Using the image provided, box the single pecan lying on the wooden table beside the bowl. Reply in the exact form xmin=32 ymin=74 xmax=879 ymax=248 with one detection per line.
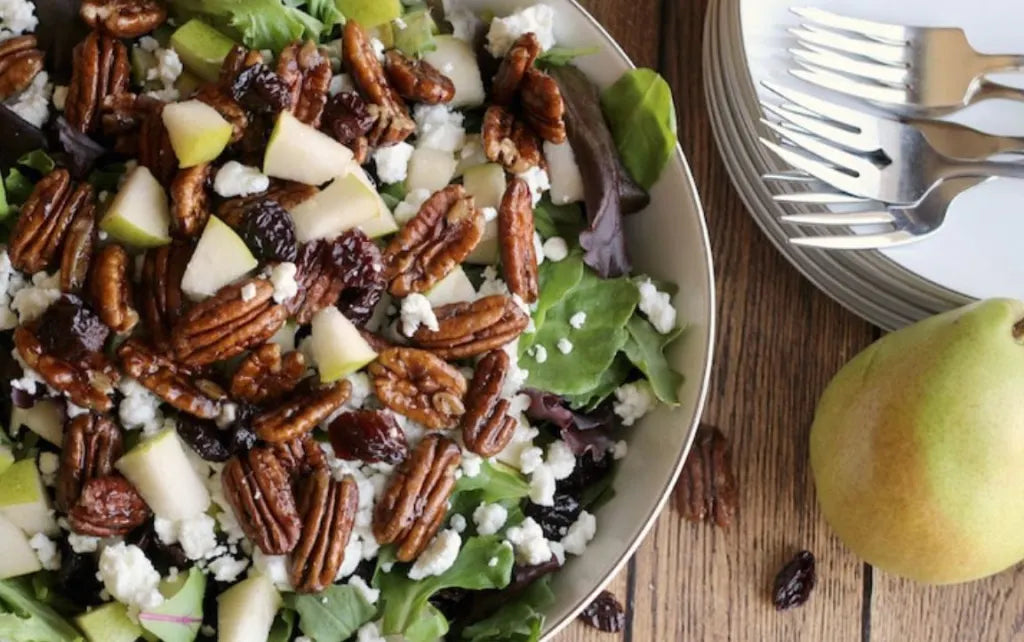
xmin=676 ymin=425 xmax=737 ymax=528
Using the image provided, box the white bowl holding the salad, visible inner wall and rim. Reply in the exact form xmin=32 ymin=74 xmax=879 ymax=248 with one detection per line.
xmin=463 ymin=0 xmax=715 ymax=640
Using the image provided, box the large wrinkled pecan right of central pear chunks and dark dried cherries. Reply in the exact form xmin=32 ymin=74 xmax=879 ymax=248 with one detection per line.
xmin=384 ymin=185 xmax=483 ymax=297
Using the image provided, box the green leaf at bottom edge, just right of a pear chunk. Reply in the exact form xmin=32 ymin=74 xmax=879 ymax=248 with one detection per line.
xmin=285 ymin=584 xmax=377 ymax=642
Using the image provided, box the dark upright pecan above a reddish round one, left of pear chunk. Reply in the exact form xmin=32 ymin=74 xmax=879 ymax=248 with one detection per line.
xmin=55 ymin=413 xmax=124 ymax=513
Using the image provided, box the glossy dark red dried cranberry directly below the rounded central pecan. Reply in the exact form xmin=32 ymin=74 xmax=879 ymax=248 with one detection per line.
xmin=328 ymin=411 xmax=409 ymax=464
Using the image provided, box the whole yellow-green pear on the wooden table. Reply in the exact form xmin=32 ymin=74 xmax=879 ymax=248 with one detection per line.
xmin=810 ymin=299 xmax=1024 ymax=584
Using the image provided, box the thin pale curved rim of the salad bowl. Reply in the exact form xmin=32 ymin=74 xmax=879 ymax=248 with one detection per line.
xmin=541 ymin=0 xmax=718 ymax=642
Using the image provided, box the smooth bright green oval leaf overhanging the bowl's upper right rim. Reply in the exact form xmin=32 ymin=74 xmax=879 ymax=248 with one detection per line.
xmin=601 ymin=69 xmax=678 ymax=189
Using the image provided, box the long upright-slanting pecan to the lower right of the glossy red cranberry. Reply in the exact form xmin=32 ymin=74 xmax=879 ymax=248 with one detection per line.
xmin=373 ymin=433 xmax=462 ymax=562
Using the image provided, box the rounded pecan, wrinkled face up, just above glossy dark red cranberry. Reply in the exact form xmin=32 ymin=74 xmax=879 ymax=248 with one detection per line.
xmin=370 ymin=348 xmax=466 ymax=430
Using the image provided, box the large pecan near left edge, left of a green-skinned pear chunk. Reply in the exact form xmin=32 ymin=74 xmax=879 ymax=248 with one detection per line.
xmin=7 ymin=169 xmax=94 ymax=273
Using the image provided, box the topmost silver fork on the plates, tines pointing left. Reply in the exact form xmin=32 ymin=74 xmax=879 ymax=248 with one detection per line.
xmin=791 ymin=7 xmax=1024 ymax=115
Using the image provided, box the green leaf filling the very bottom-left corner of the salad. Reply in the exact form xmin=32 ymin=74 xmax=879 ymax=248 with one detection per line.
xmin=0 ymin=579 xmax=84 ymax=642
